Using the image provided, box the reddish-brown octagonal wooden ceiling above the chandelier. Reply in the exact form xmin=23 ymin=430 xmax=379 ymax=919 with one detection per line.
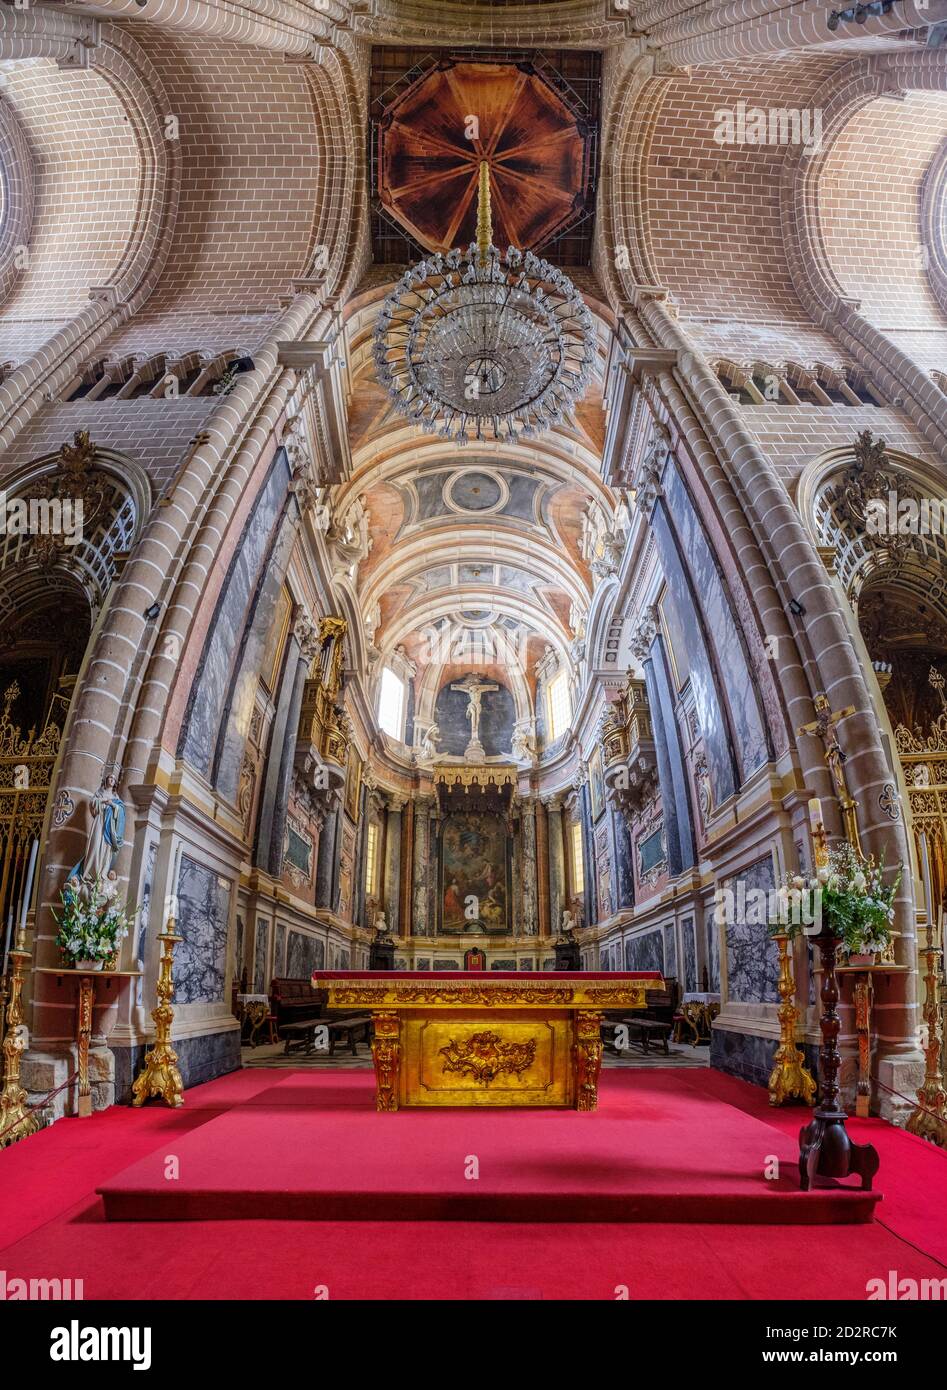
xmin=377 ymin=58 xmax=594 ymax=252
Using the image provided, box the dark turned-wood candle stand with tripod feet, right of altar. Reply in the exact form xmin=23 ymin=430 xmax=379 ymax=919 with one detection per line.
xmin=800 ymin=931 xmax=879 ymax=1193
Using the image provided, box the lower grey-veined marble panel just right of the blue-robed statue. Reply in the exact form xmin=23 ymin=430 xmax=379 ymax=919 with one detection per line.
xmin=174 ymin=855 xmax=231 ymax=1004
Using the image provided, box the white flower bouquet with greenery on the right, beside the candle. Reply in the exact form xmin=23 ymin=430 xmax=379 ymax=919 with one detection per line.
xmin=769 ymin=842 xmax=903 ymax=956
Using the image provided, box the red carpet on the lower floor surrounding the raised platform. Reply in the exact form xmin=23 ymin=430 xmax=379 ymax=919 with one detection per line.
xmin=0 ymin=1070 xmax=947 ymax=1301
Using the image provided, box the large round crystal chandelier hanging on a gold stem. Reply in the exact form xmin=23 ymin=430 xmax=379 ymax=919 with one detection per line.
xmin=374 ymin=161 xmax=595 ymax=445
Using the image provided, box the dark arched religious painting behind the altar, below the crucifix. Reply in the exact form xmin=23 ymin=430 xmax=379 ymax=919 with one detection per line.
xmin=438 ymin=812 xmax=512 ymax=935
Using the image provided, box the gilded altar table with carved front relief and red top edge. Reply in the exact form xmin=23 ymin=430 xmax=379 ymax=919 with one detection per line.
xmin=313 ymin=970 xmax=665 ymax=1111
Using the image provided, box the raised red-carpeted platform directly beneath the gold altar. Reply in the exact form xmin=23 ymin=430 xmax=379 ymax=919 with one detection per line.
xmin=97 ymin=1070 xmax=879 ymax=1225
